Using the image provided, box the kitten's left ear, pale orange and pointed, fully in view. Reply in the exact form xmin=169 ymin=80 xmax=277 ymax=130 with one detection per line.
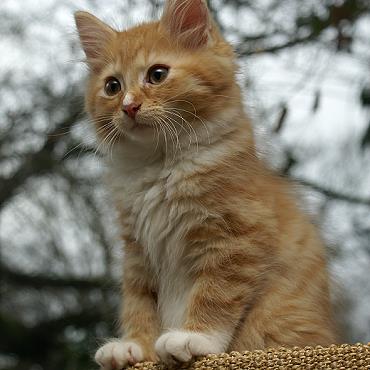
xmin=75 ymin=11 xmax=116 ymax=68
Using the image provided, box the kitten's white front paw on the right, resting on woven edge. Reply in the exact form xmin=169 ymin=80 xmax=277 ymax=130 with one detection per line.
xmin=155 ymin=330 xmax=225 ymax=364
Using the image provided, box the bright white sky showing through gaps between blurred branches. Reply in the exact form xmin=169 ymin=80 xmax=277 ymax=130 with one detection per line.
xmin=0 ymin=0 xmax=370 ymax=340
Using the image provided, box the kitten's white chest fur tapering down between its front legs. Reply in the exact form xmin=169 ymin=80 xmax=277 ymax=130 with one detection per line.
xmin=110 ymin=146 xmax=200 ymax=328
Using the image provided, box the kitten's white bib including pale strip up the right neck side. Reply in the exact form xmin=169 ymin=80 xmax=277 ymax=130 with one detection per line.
xmin=110 ymin=122 xmax=240 ymax=328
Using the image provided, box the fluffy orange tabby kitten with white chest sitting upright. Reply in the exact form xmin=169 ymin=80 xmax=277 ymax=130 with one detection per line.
xmin=76 ymin=0 xmax=335 ymax=369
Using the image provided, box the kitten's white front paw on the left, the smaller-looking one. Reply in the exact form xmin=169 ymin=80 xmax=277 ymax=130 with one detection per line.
xmin=95 ymin=340 xmax=143 ymax=370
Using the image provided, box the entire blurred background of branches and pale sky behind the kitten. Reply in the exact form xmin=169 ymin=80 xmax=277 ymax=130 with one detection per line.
xmin=0 ymin=0 xmax=370 ymax=370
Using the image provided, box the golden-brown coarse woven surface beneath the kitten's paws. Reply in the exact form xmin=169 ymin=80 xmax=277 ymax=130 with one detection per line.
xmin=129 ymin=343 xmax=370 ymax=370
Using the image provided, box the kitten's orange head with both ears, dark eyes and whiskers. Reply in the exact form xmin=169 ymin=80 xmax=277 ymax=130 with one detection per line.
xmin=75 ymin=0 xmax=243 ymax=151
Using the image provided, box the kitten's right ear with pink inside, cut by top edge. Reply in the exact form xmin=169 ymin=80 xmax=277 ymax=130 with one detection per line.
xmin=161 ymin=0 xmax=211 ymax=48
